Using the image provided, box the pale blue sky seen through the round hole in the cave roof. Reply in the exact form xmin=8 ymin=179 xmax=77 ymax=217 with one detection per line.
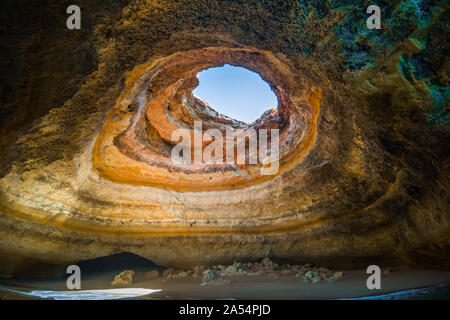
xmin=193 ymin=64 xmax=278 ymax=122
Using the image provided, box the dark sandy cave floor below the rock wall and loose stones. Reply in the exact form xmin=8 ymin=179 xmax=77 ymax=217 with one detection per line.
xmin=0 ymin=267 xmax=450 ymax=300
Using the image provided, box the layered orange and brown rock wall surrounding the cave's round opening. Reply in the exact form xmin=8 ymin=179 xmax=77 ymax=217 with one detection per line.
xmin=0 ymin=0 xmax=450 ymax=275
